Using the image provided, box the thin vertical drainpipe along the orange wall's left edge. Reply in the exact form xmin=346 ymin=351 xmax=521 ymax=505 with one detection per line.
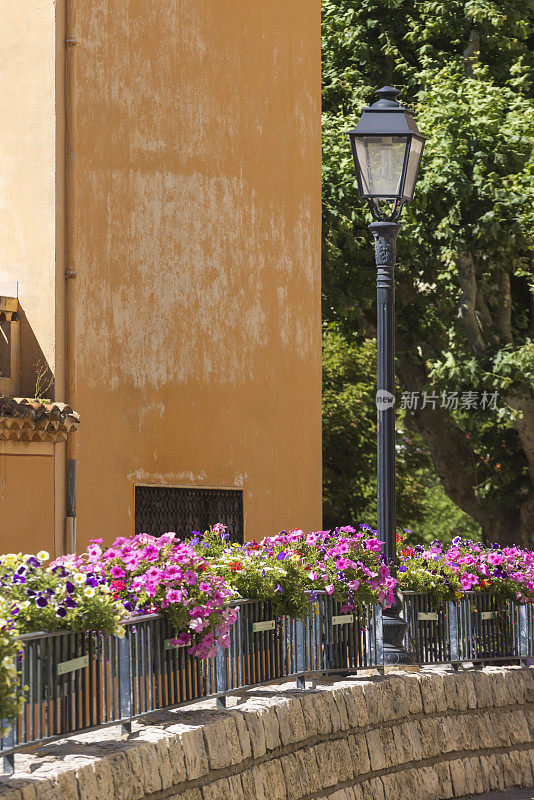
xmin=64 ymin=0 xmax=77 ymax=553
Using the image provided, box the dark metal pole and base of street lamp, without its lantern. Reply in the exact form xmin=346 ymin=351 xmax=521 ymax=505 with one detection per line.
xmin=369 ymin=222 xmax=412 ymax=664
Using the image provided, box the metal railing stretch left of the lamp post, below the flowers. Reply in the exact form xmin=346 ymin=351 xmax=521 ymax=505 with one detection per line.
xmin=0 ymin=594 xmax=383 ymax=772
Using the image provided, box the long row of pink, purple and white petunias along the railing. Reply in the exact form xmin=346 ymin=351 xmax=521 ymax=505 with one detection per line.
xmin=0 ymin=524 xmax=534 ymax=719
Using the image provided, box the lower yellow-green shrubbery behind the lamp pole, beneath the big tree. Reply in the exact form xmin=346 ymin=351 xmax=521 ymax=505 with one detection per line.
xmin=323 ymin=323 xmax=480 ymax=544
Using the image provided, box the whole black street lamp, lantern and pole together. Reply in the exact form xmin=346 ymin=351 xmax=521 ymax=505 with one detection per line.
xmin=349 ymin=86 xmax=425 ymax=664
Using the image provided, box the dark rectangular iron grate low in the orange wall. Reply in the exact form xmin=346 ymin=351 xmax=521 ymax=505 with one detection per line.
xmin=135 ymin=486 xmax=243 ymax=542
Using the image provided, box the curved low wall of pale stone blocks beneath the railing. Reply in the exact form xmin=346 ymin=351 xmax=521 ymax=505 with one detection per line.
xmin=0 ymin=668 xmax=534 ymax=800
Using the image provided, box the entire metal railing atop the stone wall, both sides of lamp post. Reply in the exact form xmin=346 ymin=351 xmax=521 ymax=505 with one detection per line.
xmin=0 ymin=592 xmax=534 ymax=772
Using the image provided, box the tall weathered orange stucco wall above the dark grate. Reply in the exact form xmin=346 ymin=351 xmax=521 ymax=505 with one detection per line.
xmin=70 ymin=0 xmax=321 ymax=546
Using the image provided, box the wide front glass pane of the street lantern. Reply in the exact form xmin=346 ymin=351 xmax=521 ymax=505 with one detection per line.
xmin=355 ymin=136 xmax=408 ymax=199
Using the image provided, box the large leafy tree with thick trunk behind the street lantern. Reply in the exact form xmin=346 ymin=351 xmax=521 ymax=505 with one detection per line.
xmin=323 ymin=0 xmax=534 ymax=545
